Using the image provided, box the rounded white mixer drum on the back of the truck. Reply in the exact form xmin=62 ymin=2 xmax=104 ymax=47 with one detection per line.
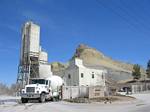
xmin=48 ymin=76 xmax=63 ymax=91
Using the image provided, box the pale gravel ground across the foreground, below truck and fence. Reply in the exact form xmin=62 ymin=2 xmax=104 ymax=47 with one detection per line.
xmin=0 ymin=93 xmax=150 ymax=112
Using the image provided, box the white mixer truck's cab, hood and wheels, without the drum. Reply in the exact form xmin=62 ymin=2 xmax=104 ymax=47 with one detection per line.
xmin=21 ymin=78 xmax=59 ymax=103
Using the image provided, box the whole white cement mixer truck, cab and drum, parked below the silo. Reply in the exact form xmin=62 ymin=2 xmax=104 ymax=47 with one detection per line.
xmin=21 ymin=76 xmax=63 ymax=103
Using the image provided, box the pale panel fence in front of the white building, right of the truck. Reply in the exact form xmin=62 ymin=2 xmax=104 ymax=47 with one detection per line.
xmin=62 ymin=86 xmax=105 ymax=99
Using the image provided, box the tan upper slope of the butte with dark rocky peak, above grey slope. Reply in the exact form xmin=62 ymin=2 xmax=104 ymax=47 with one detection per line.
xmin=73 ymin=44 xmax=145 ymax=72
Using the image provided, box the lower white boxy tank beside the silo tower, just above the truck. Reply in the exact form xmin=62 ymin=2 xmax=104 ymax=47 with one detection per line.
xmin=39 ymin=64 xmax=52 ymax=78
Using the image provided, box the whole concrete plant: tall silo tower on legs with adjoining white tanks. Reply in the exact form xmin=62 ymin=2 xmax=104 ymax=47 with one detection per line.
xmin=17 ymin=21 xmax=52 ymax=87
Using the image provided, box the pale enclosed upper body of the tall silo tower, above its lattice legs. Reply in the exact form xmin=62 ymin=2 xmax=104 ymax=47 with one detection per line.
xmin=20 ymin=22 xmax=40 ymax=64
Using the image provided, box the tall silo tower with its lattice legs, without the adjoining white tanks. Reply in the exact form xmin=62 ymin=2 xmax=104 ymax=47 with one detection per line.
xmin=17 ymin=21 xmax=40 ymax=85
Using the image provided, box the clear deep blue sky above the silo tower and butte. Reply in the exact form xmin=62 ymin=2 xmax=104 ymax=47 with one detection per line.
xmin=0 ymin=0 xmax=150 ymax=85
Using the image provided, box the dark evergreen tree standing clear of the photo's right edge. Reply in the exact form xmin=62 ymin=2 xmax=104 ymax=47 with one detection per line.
xmin=132 ymin=64 xmax=141 ymax=80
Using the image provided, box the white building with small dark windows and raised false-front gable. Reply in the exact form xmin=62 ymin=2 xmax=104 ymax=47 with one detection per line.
xmin=57 ymin=58 xmax=106 ymax=86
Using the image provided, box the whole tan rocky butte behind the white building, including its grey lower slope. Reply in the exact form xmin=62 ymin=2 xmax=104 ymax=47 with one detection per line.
xmin=51 ymin=44 xmax=145 ymax=82
